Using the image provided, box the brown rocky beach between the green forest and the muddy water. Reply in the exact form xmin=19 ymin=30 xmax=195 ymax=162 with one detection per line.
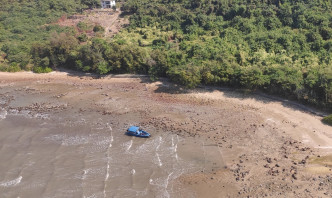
xmin=0 ymin=72 xmax=332 ymax=197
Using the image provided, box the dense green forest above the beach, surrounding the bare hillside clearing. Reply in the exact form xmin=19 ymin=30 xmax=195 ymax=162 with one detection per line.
xmin=0 ymin=0 xmax=332 ymax=110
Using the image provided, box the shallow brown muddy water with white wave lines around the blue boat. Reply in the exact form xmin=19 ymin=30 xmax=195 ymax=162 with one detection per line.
xmin=0 ymin=92 xmax=224 ymax=197
